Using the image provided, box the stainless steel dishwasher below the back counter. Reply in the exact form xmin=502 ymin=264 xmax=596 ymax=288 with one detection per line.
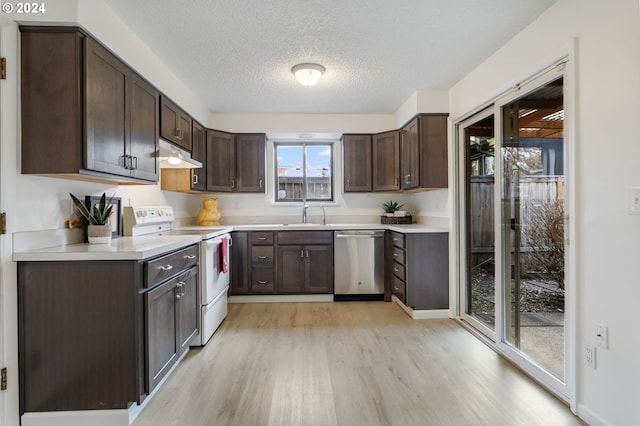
xmin=334 ymin=230 xmax=384 ymax=300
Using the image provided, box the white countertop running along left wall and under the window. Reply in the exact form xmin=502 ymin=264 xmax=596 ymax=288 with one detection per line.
xmin=13 ymin=223 xmax=449 ymax=262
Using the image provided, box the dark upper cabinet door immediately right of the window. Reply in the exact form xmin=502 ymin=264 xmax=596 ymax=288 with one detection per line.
xmin=342 ymin=135 xmax=372 ymax=192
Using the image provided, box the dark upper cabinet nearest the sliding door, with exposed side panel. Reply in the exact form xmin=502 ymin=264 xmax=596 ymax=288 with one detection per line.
xmin=400 ymin=114 xmax=448 ymax=190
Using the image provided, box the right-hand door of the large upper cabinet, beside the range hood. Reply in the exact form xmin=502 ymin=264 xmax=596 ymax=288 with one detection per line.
xmin=128 ymin=73 xmax=159 ymax=182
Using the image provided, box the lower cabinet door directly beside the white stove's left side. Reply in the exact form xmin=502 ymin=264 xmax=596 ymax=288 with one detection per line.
xmin=176 ymin=266 xmax=199 ymax=353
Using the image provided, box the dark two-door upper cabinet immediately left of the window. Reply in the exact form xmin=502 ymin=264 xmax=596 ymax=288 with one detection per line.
xmin=206 ymin=130 xmax=266 ymax=193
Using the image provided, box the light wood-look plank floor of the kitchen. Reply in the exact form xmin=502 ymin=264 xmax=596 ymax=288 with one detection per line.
xmin=134 ymin=302 xmax=582 ymax=426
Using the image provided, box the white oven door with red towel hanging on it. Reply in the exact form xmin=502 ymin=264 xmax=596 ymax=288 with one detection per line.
xmin=200 ymin=234 xmax=231 ymax=306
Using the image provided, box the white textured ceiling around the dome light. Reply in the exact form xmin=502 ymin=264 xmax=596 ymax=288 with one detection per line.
xmin=105 ymin=0 xmax=556 ymax=113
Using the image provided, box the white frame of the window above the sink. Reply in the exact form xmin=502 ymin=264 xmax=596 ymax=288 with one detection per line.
xmin=273 ymin=140 xmax=336 ymax=205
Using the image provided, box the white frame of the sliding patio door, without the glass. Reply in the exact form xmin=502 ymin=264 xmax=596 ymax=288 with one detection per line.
xmin=452 ymin=45 xmax=581 ymax=413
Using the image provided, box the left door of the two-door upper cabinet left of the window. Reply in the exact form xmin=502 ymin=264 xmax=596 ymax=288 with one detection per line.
xmin=207 ymin=130 xmax=236 ymax=192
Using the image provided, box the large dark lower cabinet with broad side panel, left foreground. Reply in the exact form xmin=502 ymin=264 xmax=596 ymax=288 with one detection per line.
xmin=18 ymin=246 xmax=198 ymax=414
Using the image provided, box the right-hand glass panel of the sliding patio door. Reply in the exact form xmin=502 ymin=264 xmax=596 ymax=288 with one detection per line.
xmin=500 ymin=78 xmax=565 ymax=380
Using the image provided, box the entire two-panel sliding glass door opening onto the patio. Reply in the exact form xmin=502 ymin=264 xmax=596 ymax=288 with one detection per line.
xmin=457 ymin=67 xmax=568 ymax=396
